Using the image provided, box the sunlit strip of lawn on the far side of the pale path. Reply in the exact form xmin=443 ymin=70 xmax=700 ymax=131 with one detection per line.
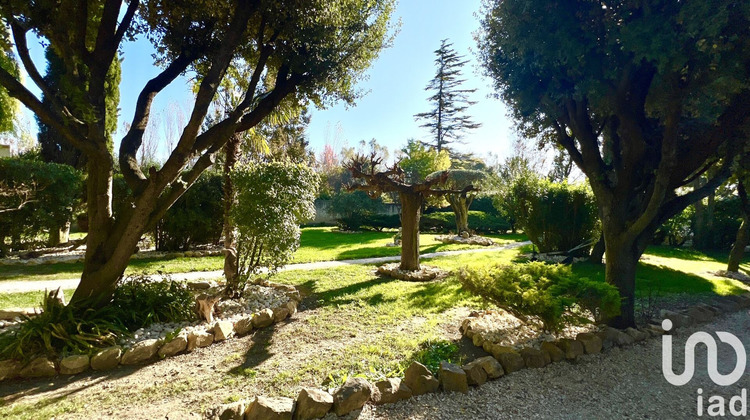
xmin=0 ymin=227 xmax=525 ymax=282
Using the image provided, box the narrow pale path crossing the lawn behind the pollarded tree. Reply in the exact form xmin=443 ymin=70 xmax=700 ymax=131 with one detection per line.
xmin=0 ymin=241 xmax=531 ymax=293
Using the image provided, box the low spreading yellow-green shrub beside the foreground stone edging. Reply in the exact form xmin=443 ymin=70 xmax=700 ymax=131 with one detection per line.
xmin=458 ymin=262 xmax=620 ymax=331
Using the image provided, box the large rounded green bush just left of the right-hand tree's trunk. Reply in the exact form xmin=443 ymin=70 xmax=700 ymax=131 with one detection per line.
xmin=510 ymin=178 xmax=599 ymax=252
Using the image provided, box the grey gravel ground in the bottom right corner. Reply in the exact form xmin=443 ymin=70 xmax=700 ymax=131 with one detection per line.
xmin=357 ymin=311 xmax=750 ymax=420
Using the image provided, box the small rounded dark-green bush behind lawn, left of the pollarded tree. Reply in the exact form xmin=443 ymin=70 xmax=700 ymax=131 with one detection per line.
xmin=328 ymin=191 xmax=388 ymax=231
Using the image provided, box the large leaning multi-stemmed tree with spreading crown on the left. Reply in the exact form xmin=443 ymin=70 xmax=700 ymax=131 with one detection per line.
xmin=0 ymin=0 xmax=393 ymax=305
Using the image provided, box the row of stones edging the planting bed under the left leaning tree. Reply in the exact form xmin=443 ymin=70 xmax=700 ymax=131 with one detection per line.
xmin=0 ymin=282 xmax=302 ymax=381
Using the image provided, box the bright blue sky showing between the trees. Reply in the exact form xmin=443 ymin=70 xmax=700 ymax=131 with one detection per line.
xmin=22 ymin=0 xmax=514 ymax=162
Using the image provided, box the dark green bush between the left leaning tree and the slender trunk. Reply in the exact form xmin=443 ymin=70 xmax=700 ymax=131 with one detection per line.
xmin=155 ymin=172 xmax=224 ymax=251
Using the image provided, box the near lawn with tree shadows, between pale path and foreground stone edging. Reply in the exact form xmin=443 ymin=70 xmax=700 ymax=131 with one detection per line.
xmin=0 ymin=243 xmax=748 ymax=418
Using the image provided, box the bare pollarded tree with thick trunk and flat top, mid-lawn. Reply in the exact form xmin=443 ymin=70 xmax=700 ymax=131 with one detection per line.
xmin=346 ymin=152 xmax=473 ymax=271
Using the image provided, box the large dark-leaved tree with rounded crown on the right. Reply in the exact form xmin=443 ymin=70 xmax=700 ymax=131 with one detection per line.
xmin=477 ymin=0 xmax=750 ymax=327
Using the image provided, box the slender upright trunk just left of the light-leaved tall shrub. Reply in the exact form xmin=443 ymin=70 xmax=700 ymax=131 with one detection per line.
xmin=222 ymin=135 xmax=240 ymax=295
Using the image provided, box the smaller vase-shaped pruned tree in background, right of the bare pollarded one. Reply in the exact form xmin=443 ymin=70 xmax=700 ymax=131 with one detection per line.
xmin=426 ymin=169 xmax=487 ymax=235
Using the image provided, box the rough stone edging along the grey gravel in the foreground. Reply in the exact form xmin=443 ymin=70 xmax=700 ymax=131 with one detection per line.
xmin=205 ymin=293 xmax=750 ymax=420
